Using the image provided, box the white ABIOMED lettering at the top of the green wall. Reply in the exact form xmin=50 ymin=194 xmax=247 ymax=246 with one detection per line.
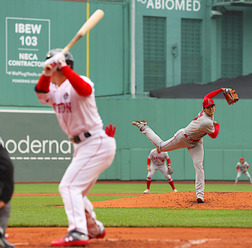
xmin=137 ymin=0 xmax=200 ymax=12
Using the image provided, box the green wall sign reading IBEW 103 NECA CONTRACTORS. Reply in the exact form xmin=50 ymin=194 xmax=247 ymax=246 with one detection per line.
xmin=6 ymin=17 xmax=50 ymax=83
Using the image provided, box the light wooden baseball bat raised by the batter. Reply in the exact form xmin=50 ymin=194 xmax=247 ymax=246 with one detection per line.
xmin=47 ymin=9 xmax=104 ymax=68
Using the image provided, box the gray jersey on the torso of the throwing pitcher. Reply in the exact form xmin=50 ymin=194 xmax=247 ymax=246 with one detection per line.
xmin=185 ymin=110 xmax=215 ymax=140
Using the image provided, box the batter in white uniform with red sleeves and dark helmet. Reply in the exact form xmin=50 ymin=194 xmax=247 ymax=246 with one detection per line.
xmin=35 ymin=49 xmax=116 ymax=246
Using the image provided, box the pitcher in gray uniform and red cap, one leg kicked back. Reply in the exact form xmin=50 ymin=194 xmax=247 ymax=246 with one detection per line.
xmin=132 ymin=88 xmax=225 ymax=203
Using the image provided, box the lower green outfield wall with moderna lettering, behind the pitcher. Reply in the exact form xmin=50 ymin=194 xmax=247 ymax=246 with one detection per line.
xmin=0 ymin=97 xmax=252 ymax=182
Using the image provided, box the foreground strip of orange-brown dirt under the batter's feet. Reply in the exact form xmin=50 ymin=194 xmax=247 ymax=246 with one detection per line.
xmin=8 ymin=227 xmax=252 ymax=248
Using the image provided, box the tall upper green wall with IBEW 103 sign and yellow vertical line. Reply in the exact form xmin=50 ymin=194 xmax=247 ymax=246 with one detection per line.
xmin=0 ymin=0 xmax=130 ymax=106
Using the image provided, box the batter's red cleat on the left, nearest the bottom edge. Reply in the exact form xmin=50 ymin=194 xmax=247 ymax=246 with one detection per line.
xmin=51 ymin=231 xmax=90 ymax=247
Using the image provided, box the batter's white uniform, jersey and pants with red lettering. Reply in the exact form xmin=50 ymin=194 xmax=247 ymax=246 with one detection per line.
xmin=36 ymin=72 xmax=116 ymax=234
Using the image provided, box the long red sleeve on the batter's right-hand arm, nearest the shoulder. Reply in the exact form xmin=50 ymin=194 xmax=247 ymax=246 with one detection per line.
xmin=60 ymin=66 xmax=92 ymax=96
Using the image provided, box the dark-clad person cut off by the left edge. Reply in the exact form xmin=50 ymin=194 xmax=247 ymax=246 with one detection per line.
xmin=0 ymin=138 xmax=15 ymax=248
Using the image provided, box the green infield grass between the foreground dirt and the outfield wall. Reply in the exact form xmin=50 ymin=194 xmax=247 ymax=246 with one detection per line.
xmin=9 ymin=182 xmax=252 ymax=228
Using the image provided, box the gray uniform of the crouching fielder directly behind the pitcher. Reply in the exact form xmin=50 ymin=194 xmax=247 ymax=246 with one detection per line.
xmin=147 ymin=148 xmax=171 ymax=181
